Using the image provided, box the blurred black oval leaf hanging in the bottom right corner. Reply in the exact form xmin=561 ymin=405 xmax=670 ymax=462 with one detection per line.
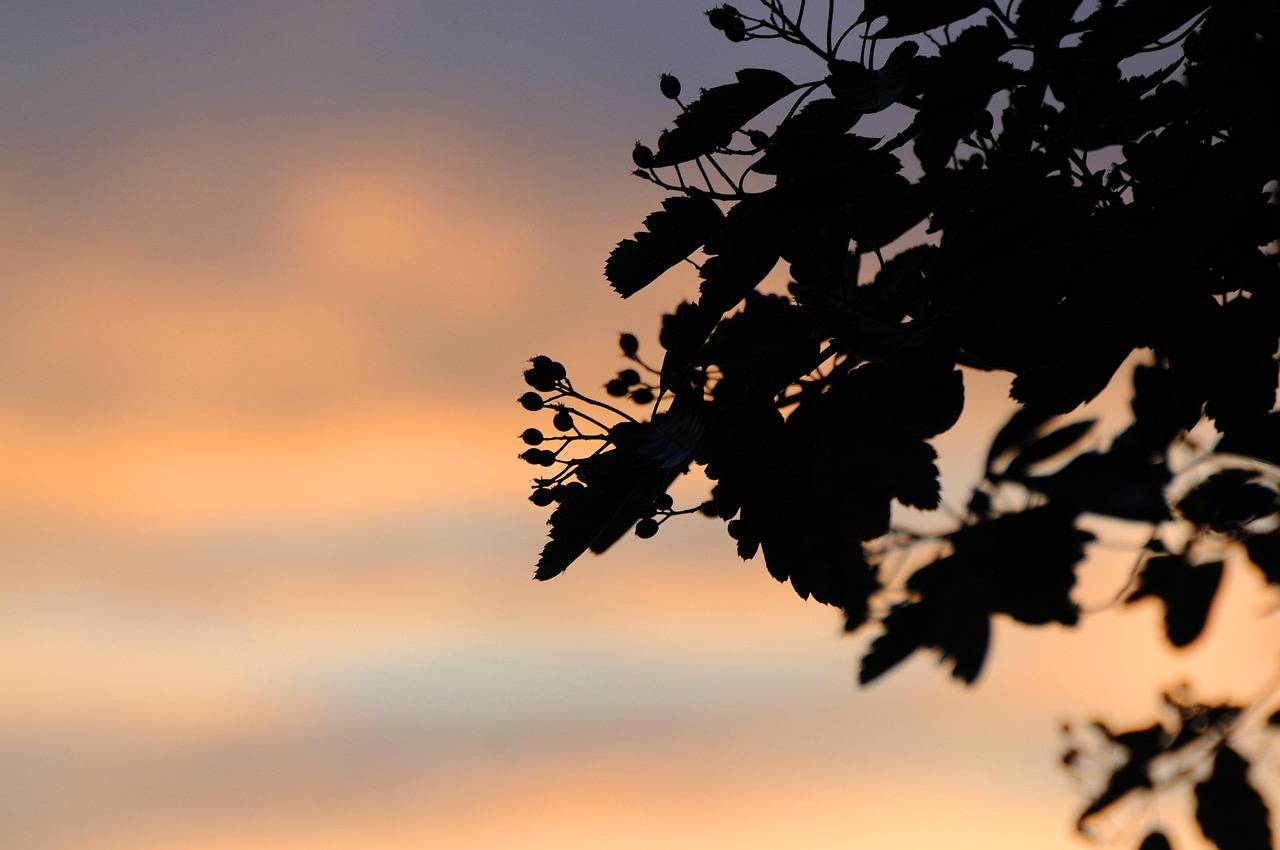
xmin=1196 ymin=746 xmax=1271 ymax=850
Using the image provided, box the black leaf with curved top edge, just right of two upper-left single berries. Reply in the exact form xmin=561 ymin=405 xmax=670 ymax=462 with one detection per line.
xmin=653 ymin=68 xmax=796 ymax=168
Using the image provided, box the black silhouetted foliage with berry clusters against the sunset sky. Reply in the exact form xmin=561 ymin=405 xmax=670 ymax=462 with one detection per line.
xmin=521 ymin=0 xmax=1280 ymax=850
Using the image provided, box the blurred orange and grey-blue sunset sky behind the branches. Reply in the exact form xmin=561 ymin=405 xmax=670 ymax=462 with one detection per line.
xmin=0 ymin=0 xmax=1280 ymax=850
